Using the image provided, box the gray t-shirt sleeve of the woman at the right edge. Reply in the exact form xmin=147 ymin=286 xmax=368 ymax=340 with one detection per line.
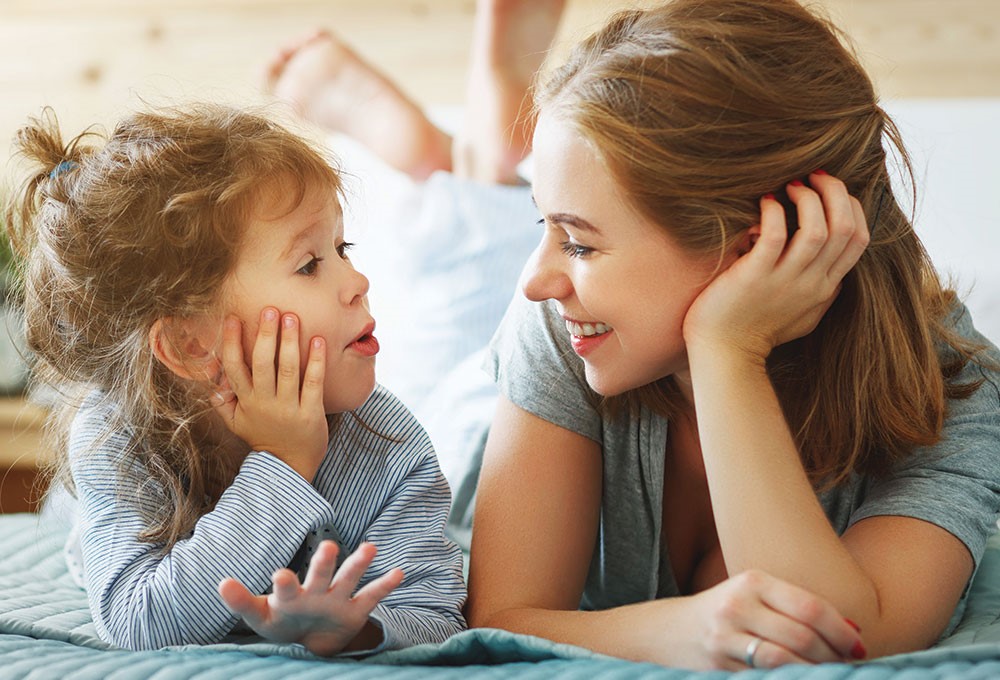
xmin=850 ymin=308 xmax=1000 ymax=568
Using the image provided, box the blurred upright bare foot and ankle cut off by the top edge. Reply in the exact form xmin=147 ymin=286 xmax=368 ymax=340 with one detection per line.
xmin=454 ymin=0 xmax=566 ymax=184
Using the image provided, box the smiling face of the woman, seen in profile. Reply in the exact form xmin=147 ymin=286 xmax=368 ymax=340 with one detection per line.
xmin=522 ymin=112 xmax=719 ymax=396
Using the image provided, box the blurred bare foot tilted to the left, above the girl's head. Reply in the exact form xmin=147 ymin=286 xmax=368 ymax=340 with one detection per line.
xmin=265 ymin=31 xmax=451 ymax=180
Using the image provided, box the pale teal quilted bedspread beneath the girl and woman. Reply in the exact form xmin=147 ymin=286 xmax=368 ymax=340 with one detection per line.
xmin=0 ymin=515 xmax=1000 ymax=680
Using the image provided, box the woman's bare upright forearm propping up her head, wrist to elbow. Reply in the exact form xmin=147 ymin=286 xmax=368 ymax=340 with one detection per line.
xmin=689 ymin=347 xmax=880 ymax=625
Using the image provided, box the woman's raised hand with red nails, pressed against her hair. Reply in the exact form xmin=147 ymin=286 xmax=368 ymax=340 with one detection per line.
xmin=684 ymin=171 xmax=869 ymax=361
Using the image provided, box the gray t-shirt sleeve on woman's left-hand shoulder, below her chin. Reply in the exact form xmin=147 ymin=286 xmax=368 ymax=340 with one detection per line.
xmin=485 ymin=295 xmax=603 ymax=443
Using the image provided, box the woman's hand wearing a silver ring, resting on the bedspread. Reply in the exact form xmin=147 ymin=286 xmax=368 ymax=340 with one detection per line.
xmin=672 ymin=571 xmax=866 ymax=671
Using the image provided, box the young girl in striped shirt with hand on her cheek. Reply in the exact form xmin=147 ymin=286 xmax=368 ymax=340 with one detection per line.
xmin=10 ymin=106 xmax=465 ymax=654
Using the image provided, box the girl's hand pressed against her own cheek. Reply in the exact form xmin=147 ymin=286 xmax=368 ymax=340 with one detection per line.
xmin=215 ymin=307 xmax=330 ymax=482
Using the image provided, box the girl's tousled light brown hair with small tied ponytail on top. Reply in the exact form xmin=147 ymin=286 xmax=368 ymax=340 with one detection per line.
xmin=7 ymin=105 xmax=341 ymax=548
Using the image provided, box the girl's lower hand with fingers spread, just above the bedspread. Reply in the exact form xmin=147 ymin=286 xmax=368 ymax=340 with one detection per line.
xmin=219 ymin=541 xmax=403 ymax=656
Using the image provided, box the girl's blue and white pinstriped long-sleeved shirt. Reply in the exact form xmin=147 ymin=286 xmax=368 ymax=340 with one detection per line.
xmin=67 ymin=386 xmax=465 ymax=651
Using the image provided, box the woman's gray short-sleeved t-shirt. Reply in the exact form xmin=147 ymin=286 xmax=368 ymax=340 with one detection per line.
xmin=487 ymin=296 xmax=1000 ymax=628
